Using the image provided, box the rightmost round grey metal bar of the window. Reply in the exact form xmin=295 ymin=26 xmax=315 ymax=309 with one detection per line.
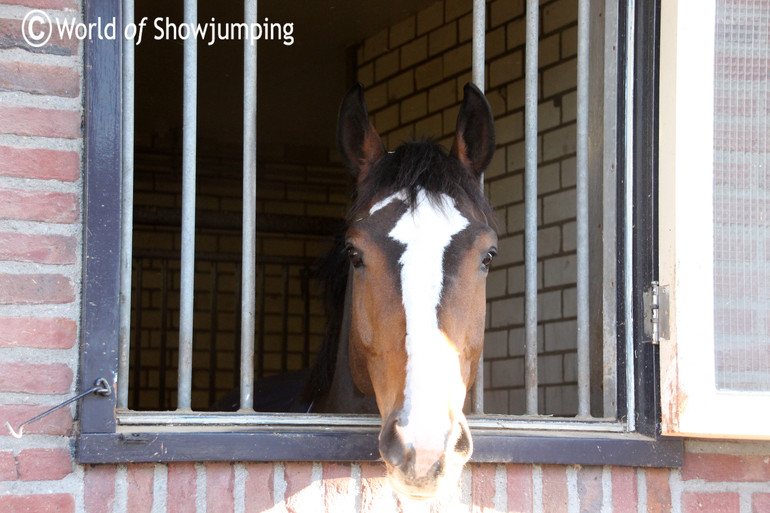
xmin=576 ymin=0 xmax=591 ymax=416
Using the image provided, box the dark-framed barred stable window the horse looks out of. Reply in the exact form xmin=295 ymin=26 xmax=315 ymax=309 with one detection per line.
xmin=79 ymin=0 xmax=682 ymax=465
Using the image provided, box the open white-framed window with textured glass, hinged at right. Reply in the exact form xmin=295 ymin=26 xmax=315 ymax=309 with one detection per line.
xmin=660 ymin=0 xmax=770 ymax=438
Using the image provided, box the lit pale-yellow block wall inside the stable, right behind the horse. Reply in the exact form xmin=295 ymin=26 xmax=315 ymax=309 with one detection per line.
xmin=357 ymin=0 xmax=577 ymax=415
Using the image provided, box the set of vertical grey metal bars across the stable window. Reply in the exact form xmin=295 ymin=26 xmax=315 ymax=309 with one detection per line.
xmin=117 ymin=0 xmax=633 ymax=421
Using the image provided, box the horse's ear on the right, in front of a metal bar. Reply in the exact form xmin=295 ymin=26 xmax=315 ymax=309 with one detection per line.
xmin=450 ymin=83 xmax=495 ymax=176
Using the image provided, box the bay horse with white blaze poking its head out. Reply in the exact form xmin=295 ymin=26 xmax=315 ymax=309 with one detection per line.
xmin=305 ymin=84 xmax=497 ymax=499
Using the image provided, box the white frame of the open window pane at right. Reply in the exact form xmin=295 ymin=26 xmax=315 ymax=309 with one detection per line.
xmin=660 ymin=0 xmax=770 ymax=439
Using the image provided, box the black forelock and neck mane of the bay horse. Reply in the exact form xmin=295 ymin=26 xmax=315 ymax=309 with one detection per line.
xmin=300 ymin=140 xmax=494 ymax=406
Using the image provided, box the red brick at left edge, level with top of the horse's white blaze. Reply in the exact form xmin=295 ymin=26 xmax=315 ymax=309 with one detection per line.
xmin=0 ymin=189 xmax=80 ymax=223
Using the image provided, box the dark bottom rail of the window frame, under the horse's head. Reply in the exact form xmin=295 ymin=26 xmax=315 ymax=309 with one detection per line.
xmin=78 ymin=428 xmax=684 ymax=467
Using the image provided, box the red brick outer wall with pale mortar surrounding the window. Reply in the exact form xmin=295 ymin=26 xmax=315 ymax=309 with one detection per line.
xmin=0 ymin=0 xmax=770 ymax=513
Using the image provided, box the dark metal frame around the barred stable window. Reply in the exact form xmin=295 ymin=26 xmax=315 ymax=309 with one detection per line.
xmin=78 ymin=0 xmax=683 ymax=467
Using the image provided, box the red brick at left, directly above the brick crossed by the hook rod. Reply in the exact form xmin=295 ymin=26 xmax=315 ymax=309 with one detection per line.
xmin=0 ymin=362 xmax=73 ymax=394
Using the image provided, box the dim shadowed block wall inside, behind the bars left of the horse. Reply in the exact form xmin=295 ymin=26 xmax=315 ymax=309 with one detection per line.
xmin=129 ymin=150 xmax=351 ymax=410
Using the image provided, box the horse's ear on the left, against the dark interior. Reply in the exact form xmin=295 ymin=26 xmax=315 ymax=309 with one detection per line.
xmin=337 ymin=84 xmax=385 ymax=182
